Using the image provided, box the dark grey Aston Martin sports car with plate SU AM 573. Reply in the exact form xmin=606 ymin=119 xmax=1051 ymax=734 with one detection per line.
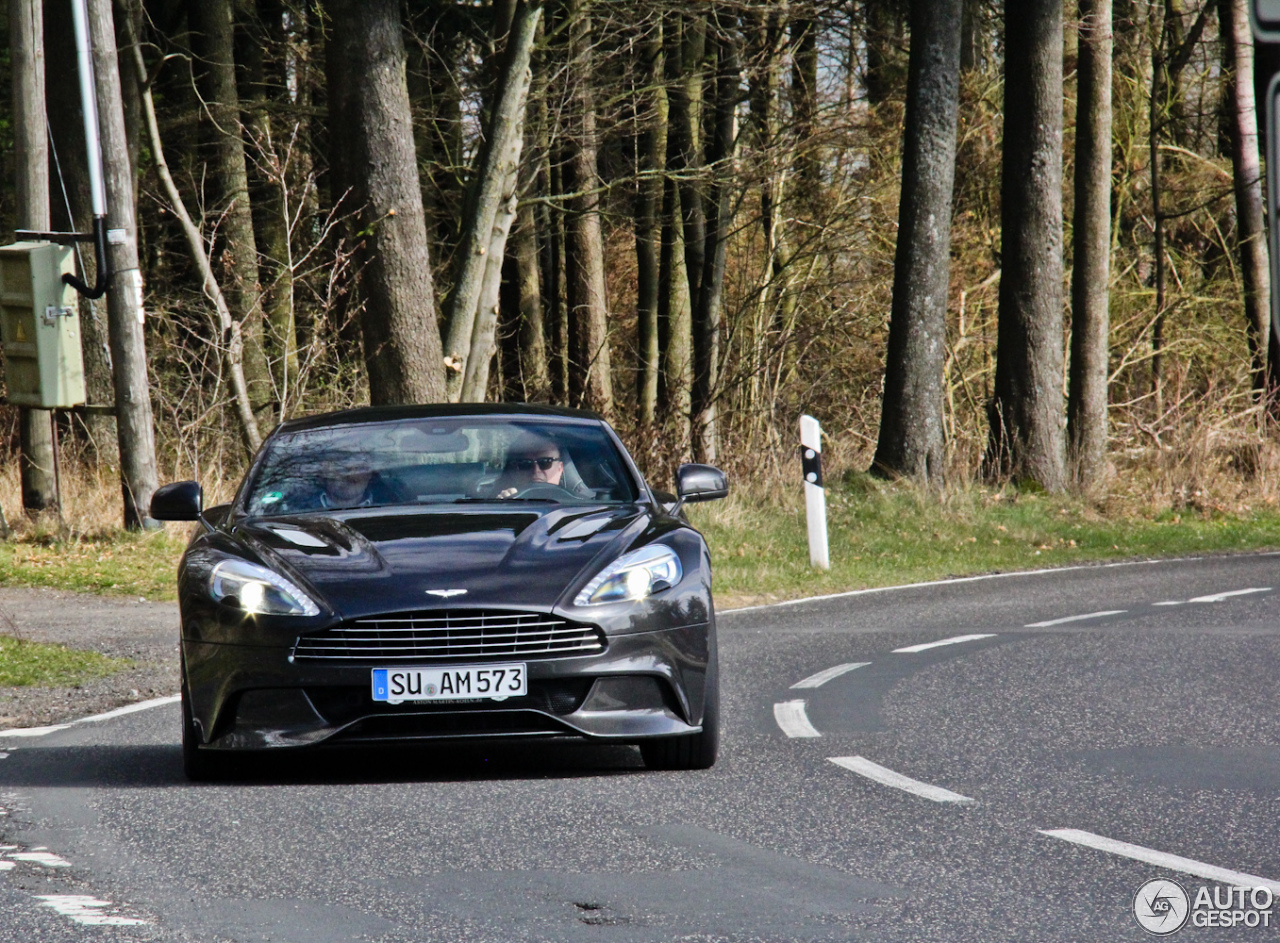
xmin=151 ymin=404 xmax=727 ymax=779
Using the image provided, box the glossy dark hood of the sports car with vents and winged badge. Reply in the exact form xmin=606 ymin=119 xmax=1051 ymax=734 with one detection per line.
xmin=236 ymin=505 xmax=653 ymax=619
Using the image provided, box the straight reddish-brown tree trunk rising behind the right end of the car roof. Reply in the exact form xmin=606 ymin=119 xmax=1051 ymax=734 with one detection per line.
xmin=564 ymin=0 xmax=613 ymax=417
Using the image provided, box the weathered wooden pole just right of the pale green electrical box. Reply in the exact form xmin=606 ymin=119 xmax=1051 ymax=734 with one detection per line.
xmin=88 ymin=0 xmax=157 ymax=530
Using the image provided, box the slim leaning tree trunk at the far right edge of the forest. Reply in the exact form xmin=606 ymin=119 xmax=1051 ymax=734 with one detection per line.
xmin=1220 ymin=0 xmax=1275 ymax=392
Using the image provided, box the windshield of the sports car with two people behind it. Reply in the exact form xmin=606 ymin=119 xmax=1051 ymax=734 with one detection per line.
xmin=246 ymin=418 xmax=637 ymax=516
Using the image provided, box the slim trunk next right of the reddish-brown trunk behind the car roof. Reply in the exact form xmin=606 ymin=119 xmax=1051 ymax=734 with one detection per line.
xmin=635 ymin=17 xmax=667 ymax=426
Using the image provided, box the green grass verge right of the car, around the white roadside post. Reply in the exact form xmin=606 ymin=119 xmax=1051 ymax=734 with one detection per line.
xmin=689 ymin=473 xmax=1280 ymax=609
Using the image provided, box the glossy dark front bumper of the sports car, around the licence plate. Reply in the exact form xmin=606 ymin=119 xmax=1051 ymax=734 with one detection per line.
xmin=182 ymin=622 xmax=716 ymax=750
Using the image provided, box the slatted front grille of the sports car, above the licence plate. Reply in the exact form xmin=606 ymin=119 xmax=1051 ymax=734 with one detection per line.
xmin=293 ymin=609 xmax=604 ymax=664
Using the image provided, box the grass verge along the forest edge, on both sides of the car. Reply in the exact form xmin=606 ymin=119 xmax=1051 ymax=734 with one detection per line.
xmin=0 ymin=473 xmax=1280 ymax=609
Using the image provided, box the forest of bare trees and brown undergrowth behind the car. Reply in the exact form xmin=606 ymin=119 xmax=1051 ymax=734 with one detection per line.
xmin=0 ymin=0 xmax=1280 ymax=603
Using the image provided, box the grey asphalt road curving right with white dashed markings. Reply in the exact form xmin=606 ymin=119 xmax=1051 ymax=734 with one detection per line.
xmin=0 ymin=555 xmax=1280 ymax=943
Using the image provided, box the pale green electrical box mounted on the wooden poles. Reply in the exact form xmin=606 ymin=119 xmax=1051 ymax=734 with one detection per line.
xmin=0 ymin=242 xmax=84 ymax=409
